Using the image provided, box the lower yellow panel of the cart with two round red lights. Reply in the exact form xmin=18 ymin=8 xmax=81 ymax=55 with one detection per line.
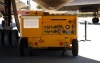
xmin=28 ymin=35 xmax=75 ymax=47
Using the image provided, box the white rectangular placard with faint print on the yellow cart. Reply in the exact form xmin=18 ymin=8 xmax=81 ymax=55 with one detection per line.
xmin=24 ymin=18 xmax=39 ymax=28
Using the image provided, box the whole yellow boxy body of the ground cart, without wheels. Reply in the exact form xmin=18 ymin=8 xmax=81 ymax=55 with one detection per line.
xmin=21 ymin=12 xmax=77 ymax=48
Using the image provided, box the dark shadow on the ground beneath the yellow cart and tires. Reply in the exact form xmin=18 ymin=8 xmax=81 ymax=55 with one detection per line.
xmin=0 ymin=48 xmax=100 ymax=63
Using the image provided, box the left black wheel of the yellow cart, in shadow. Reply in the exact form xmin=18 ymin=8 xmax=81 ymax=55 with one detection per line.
xmin=19 ymin=38 xmax=29 ymax=56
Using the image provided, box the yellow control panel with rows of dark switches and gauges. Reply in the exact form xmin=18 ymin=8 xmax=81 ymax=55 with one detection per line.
xmin=42 ymin=16 xmax=76 ymax=34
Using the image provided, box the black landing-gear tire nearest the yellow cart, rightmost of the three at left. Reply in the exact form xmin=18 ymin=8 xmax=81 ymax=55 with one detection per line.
xmin=11 ymin=30 xmax=18 ymax=47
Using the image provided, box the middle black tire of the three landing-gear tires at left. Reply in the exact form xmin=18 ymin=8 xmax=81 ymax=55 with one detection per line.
xmin=4 ymin=30 xmax=11 ymax=47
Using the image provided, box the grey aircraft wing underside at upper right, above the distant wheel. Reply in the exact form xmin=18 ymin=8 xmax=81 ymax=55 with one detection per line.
xmin=59 ymin=0 xmax=100 ymax=12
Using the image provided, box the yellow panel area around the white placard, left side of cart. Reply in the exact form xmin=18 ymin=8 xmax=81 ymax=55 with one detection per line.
xmin=21 ymin=18 xmax=42 ymax=37
